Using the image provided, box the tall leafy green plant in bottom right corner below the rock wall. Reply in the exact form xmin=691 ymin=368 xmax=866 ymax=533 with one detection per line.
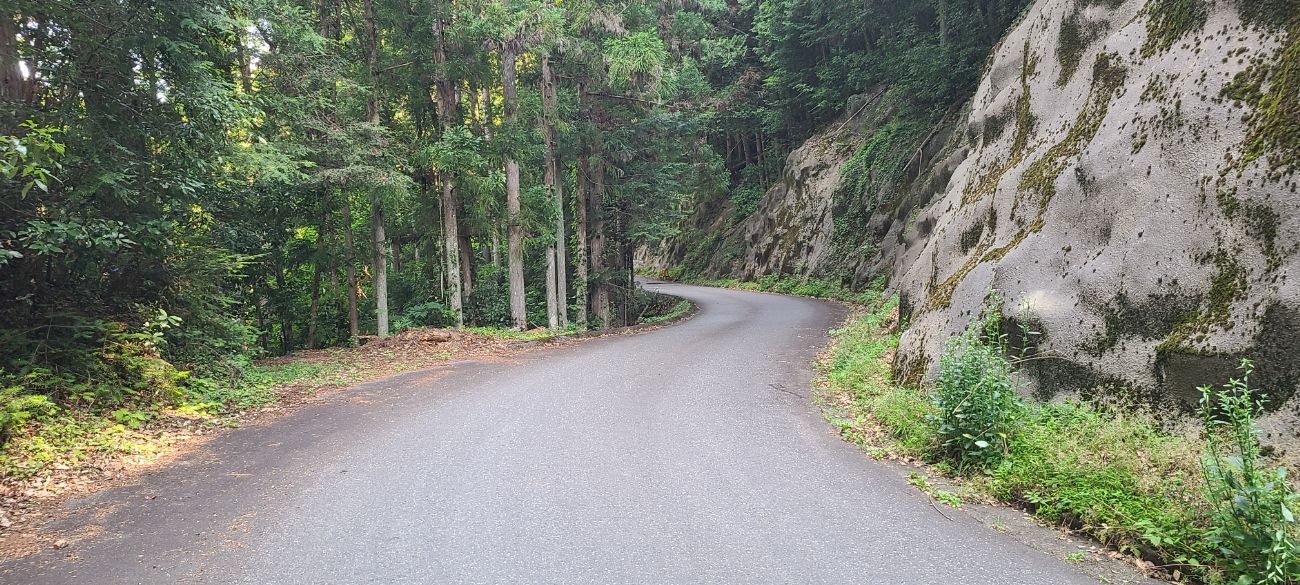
xmin=1200 ymin=360 xmax=1300 ymax=584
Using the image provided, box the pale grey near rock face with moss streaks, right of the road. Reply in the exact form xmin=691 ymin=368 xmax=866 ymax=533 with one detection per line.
xmin=888 ymin=0 xmax=1300 ymax=433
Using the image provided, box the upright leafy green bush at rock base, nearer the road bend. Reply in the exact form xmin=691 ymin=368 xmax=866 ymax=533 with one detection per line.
xmin=931 ymin=295 xmax=1024 ymax=471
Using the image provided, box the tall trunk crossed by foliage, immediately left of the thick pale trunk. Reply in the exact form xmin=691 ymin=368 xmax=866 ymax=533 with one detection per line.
xmin=433 ymin=0 xmax=465 ymax=328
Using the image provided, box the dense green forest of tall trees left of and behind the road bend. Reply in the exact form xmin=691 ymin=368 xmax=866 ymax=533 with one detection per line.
xmin=0 ymin=0 xmax=1026 ymax=423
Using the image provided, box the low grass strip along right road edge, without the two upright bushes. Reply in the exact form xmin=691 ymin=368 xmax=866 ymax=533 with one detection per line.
xmin=691 ymin=278 xmax=1290 ymax=582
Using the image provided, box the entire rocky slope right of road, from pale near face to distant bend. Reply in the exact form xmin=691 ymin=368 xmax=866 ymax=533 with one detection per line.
xmin=660 ymin=0 xmax=1300 ymax=442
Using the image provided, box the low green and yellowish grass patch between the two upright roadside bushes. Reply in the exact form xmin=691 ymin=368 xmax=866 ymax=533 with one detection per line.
xmin=975 ymin=402 xmax=1213 ymax=564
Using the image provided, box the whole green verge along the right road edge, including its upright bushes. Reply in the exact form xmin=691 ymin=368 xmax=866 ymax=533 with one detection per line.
xmin=686 ymin=271 xmax=1300 ymax=584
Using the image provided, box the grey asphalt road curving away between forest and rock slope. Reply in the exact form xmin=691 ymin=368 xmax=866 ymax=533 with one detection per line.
xmin=0 ymin=280 xmax=1092 ymax=585
